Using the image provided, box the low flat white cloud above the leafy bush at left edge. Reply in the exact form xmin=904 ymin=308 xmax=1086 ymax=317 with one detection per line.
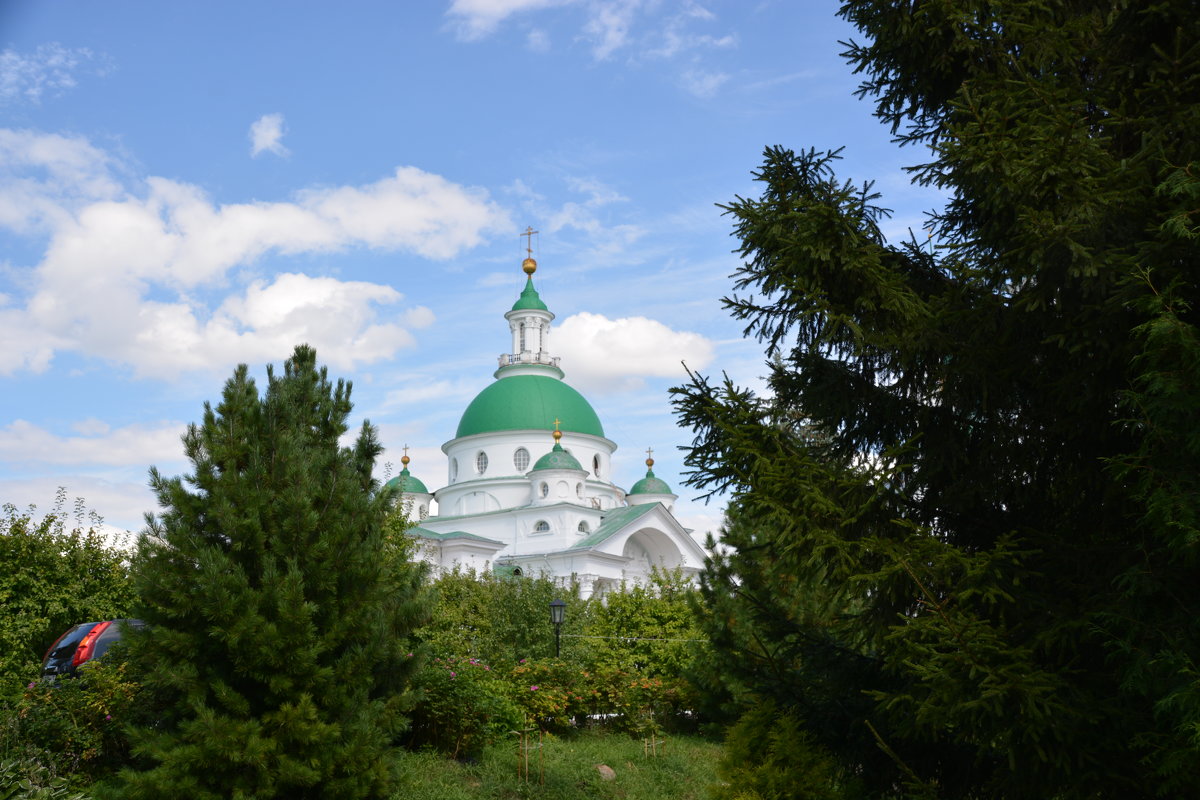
xmin=0 ymin=420 xmax=187 ymax=469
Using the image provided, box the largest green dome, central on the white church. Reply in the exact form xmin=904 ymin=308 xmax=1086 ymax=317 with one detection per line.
xmin=455 ymin=375 xmax=604 ymax=438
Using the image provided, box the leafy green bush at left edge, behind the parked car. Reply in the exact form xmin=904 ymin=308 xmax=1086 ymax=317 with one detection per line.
xmin=0 ymin=489 xmax=133 ymax=698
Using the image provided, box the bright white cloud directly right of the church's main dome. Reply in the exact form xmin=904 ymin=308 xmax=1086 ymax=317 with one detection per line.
xmin=551 ymin=312 xmax=714 ymax=392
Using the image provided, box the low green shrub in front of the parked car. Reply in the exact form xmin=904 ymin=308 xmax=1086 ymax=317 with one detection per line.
xmin=4 ymin=648 xmax=146 ymax=787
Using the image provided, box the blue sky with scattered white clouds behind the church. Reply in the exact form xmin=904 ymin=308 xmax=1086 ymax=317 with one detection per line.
xmin=0 ymin=0 xmax=935 ymax=533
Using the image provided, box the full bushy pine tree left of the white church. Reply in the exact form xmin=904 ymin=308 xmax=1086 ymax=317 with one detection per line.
xmin=118 ymin=345 xmax=425 ymax=799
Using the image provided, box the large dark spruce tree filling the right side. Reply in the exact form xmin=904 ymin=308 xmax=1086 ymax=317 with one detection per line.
xmin=677 ymin=0 xmax=1200 ymax=798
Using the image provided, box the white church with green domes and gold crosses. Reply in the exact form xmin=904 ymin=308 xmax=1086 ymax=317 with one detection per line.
xmin=388 ymin=247 xmax=704 ymax=597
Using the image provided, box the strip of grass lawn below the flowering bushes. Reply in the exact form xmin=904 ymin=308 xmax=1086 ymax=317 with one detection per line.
xmin=392 ymin=732 xmax=721 ymax=800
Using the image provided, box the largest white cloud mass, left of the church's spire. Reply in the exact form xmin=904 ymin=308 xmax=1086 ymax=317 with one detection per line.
xmin=0 ymin=131 xmax=509 ymax=375
